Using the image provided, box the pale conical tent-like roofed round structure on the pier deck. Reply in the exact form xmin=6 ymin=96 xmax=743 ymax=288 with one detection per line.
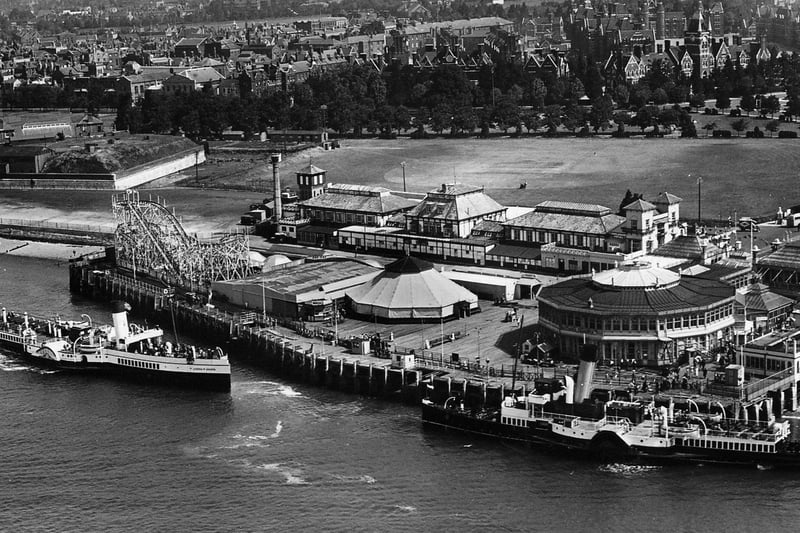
xmin=347 ymin=257 xmax=478 ymax=319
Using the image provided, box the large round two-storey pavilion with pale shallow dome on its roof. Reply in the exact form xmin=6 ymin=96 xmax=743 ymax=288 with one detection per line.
xmin=539 ymin=262 xmax=736 ymax=367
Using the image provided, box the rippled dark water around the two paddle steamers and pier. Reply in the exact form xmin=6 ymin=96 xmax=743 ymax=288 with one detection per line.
xmin=0 ymin=252 xmax=800 ymax=532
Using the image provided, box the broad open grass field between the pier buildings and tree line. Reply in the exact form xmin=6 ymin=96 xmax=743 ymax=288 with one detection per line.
xmin=230 ymin=137 xmax=800 ymax=219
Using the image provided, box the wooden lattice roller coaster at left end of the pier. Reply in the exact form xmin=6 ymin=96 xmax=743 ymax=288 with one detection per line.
xmin=111 ymin=190 xmax=252 ymax=290
